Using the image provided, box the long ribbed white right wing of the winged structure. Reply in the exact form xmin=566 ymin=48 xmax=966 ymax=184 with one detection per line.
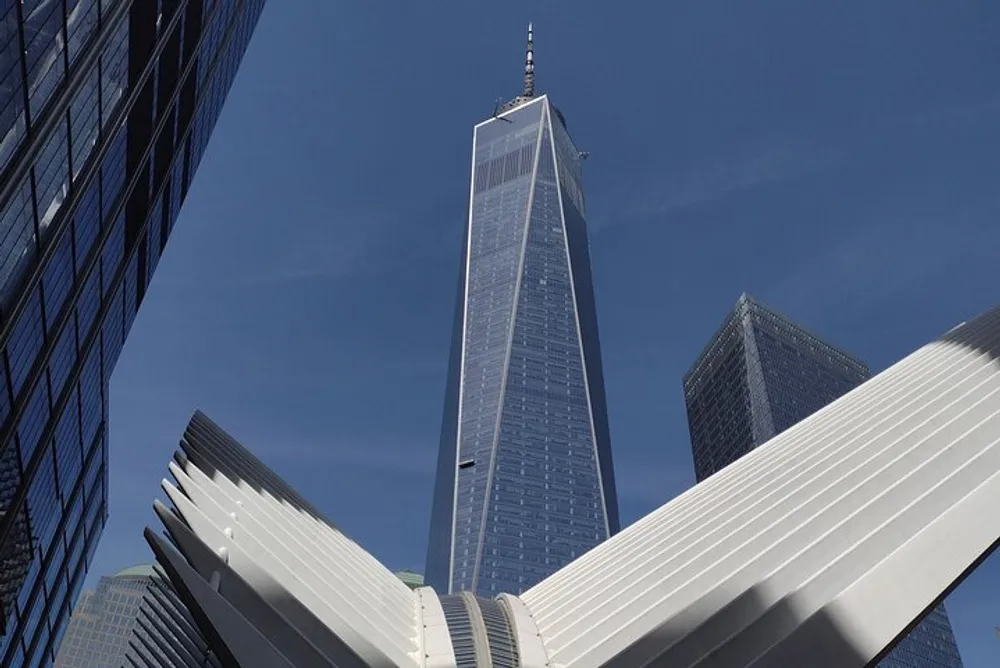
xmin=521 ymin=311 xmax=1000 ymax=668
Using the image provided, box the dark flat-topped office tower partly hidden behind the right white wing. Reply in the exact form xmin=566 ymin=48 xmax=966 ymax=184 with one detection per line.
xmin=684 ymin=294 xmax=962 ymax=668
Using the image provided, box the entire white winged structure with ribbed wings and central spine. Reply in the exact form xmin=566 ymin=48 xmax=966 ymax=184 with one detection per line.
xmin=146 ymin=309 xmax=1000 ymax=668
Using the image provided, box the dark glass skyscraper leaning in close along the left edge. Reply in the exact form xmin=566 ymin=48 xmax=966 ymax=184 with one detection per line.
xmin=0 ymin=0 xmax=263 ymax=666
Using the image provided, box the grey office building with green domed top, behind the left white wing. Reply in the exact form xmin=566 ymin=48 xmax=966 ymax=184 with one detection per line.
xmin=53 ymin=565 xmax=218 ymax=668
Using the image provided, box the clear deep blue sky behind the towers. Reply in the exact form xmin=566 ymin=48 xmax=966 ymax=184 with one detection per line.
xmin=93 ymin=0 xmax=1000 ymax=668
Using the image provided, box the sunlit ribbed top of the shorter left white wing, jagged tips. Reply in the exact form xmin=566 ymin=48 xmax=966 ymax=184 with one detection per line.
xmin=164 ymin=413 xmax=419 ymax=666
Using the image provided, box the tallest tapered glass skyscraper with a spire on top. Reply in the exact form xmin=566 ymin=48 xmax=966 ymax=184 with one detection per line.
xmin=426 ymin=26 xmax=618 ymax=596
